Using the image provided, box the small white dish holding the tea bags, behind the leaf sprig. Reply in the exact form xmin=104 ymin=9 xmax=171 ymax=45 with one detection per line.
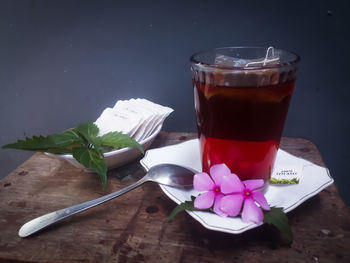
xmin=46 ymin=125 xmax=162 ymax=172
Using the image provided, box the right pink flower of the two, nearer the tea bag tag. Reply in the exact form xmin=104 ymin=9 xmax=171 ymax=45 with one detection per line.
xmin=219 ymin=174 xmax=270 ymax=224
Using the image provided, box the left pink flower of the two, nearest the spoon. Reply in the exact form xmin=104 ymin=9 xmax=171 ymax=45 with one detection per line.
xmin=193 ymin=164 xmax=231 ymax=217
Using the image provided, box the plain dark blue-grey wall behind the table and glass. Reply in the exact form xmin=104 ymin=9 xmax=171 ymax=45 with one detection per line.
xmin=0 ymin=0 xmax=350 ymax=205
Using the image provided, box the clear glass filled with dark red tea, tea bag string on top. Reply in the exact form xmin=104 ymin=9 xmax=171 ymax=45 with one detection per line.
xmin=190 ymin=47 xmax=300 ymax=182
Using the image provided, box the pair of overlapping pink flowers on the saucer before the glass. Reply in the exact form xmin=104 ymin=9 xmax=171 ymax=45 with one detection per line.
xmin=193 ymin=164 xmax=270 ymax=224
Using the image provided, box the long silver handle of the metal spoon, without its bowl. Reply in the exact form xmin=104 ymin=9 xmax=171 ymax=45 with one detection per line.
xmin=18 ymin=176 xmax=147 ymax=237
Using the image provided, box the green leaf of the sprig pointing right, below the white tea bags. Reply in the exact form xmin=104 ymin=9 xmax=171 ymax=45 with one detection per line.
xmin=95 ymin=132 xmax=144 ymax=153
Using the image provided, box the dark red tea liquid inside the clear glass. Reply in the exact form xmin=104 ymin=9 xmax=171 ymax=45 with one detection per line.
xmin=193 ymin=75 xmax=294 ymax=181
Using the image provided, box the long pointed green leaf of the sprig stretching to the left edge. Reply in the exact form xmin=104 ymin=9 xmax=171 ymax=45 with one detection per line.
xmin=2 ymin=130 xmax=83 ymax=153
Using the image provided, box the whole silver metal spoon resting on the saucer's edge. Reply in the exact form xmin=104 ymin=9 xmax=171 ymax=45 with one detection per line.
xmin=18 ymin=164 xmax=194 ymax=237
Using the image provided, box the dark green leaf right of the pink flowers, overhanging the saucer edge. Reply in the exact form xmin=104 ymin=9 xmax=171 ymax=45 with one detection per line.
xmin=264 ymin=207 xmax=293 ymax=245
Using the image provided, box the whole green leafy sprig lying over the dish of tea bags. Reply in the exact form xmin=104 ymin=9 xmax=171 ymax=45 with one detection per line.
xmin=1 ymin=121 xmax=144 ymax=187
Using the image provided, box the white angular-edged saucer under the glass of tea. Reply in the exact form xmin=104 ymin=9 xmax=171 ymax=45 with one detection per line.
xmin=140 ymin=139 xmax=333 ymax=234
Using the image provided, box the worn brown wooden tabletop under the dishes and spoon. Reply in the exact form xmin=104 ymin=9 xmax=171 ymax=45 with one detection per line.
xmin=0 ymin=132 xmax=350 ymax=263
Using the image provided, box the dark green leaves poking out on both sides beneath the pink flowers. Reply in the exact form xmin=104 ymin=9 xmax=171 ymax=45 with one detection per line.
xmin=168 ymin=200 xmax=293 ymax=245
